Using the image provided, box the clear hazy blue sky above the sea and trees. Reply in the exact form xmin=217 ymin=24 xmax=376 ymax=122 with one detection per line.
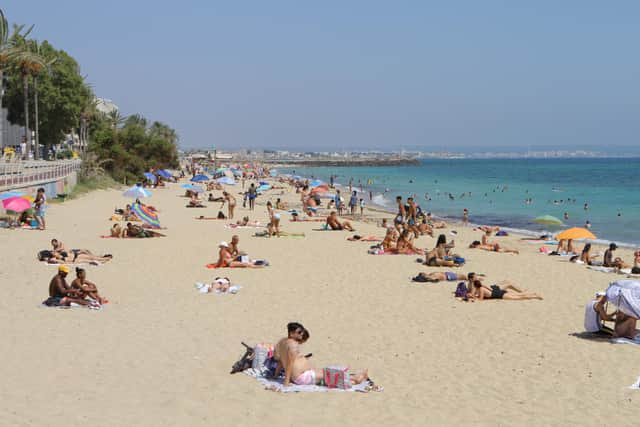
xmin=2 ymin=0 xmax=640 ymax=149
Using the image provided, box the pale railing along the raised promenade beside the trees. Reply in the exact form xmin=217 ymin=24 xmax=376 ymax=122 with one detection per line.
xmin=0 ymin=159 xmax=82 ymax=191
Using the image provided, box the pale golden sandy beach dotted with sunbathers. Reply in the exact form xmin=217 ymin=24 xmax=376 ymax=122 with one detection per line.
xmin=0 ymin=179 xmax=640 ymax=426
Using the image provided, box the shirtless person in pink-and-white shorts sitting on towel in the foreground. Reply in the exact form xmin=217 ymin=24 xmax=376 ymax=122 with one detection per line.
xmin=273 ymin=322 xmax=369 ymax=387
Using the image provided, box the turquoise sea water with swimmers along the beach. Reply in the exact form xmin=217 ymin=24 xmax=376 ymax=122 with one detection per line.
xmin=278 ymin=158 xmax=640 ymax=246
